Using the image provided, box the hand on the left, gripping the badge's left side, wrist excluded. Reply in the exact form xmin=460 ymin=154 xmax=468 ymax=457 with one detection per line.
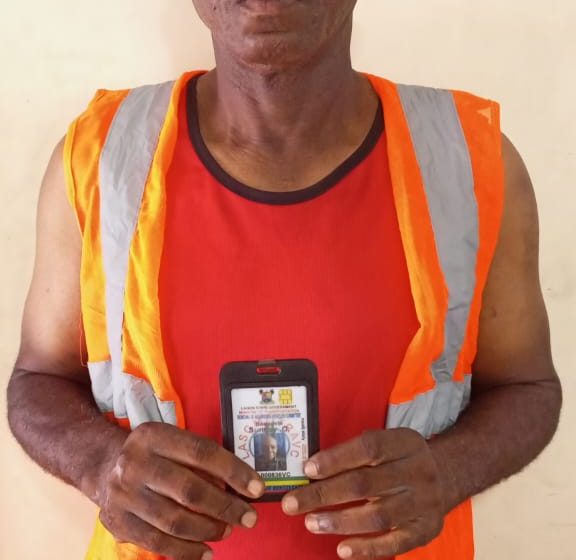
xmin=98 ymin=423 xmax=264 ymax=560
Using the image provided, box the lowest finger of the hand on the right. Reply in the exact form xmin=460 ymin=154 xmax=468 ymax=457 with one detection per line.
xmin=338 ymin=521 xmax=436 ymax=560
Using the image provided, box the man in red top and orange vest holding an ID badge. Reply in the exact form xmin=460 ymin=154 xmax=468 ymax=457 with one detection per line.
xmin=8 ymin=0 xmax=561 ymax=560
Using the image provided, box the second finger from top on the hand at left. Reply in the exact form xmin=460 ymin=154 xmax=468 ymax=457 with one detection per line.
xmin=146 ymin=457 xmax=257 ymax=528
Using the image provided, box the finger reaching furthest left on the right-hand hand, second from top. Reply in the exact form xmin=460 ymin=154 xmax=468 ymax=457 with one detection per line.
xmin=282 ymin=467 xmax=404 ymax=515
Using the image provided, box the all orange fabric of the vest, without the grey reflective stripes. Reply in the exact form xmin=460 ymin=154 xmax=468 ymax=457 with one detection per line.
xmin=65 ymin=73 xmax=503 ymax=560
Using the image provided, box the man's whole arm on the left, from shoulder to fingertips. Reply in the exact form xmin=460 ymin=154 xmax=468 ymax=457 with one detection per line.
xmin=8 ymin=143 xmax=264 ymax=560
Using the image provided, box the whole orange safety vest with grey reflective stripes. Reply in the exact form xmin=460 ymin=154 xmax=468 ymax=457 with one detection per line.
xmin=64 ymin=72 xmax=504 ymax=560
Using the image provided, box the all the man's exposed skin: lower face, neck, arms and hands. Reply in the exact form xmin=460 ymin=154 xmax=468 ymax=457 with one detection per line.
xmin=8 ymin=0 xmax=561 ymax=559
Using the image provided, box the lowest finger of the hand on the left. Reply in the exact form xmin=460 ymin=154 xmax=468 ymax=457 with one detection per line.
xmin=101 ymin=512 xmax=213 ymax=560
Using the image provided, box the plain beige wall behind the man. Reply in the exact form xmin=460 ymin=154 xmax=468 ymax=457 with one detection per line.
xmin=0 ymin=0 xmax=576 ymax=560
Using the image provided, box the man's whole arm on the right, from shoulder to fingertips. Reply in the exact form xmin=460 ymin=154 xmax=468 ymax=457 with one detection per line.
xmin=283 ymin=138 xmax=562 ymax=558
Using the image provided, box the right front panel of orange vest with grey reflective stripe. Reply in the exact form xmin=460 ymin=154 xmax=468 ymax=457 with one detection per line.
xmin=364 ymin=77 xmax=503 ymax=436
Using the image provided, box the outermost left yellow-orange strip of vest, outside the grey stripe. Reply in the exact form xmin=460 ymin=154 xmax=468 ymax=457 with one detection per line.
xmin=63 ymin=90 xmax=128 ymax=362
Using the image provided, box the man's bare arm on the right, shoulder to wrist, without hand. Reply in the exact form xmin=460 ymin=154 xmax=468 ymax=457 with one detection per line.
xmin=430 ymin=136 xmax=562 ymax=509
